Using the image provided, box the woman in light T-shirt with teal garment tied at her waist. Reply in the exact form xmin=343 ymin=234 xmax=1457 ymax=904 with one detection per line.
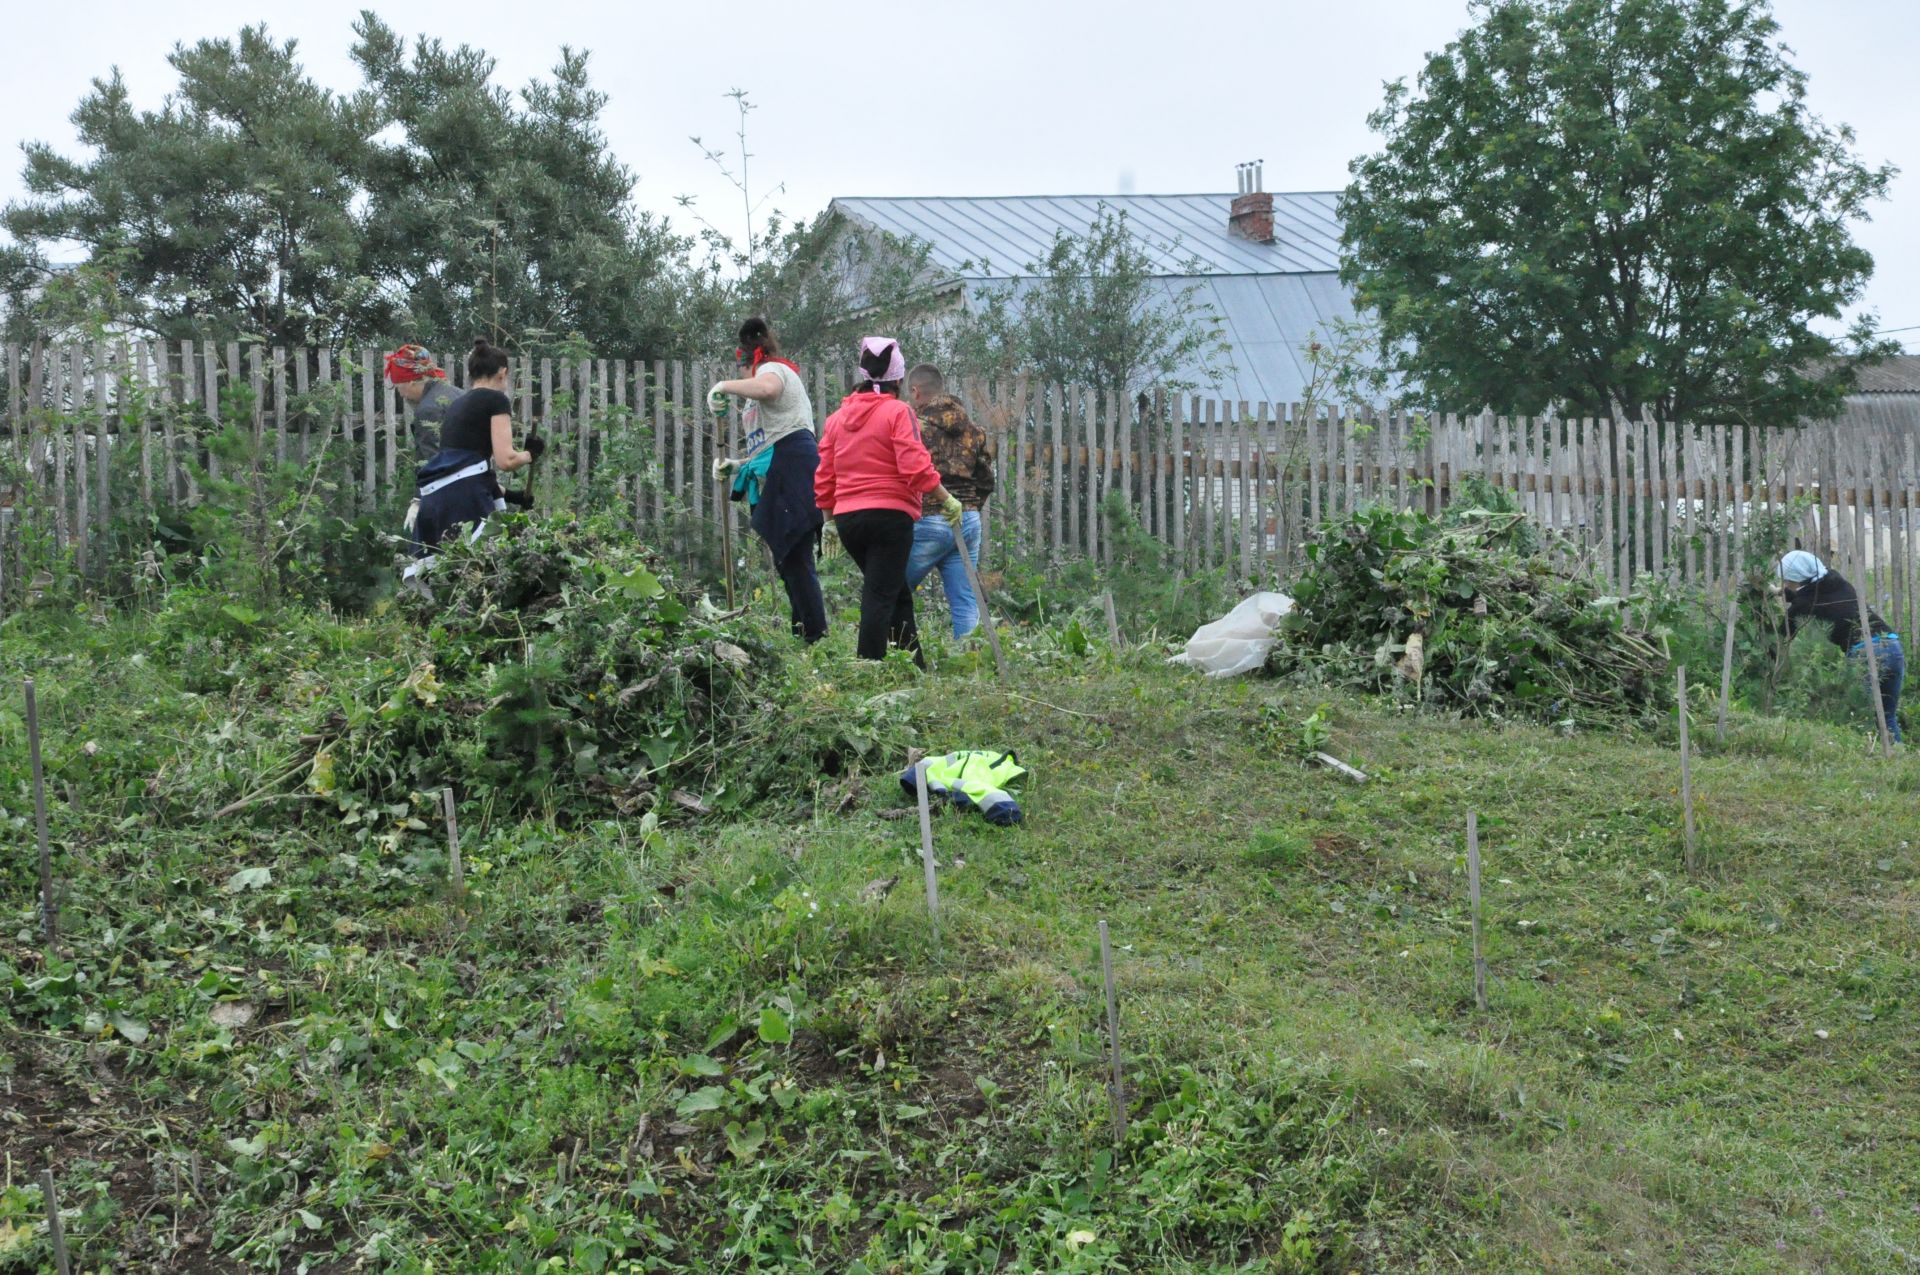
xmin=707 ymin=317 xmax=828 ymax=645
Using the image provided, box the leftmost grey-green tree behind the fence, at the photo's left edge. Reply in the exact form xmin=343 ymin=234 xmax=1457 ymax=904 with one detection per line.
xmin=0 ymin=27 xmax=380 ymax=344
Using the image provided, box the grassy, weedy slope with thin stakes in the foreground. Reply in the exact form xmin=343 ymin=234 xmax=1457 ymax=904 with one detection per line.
xmin=0 ymin=595 xmax=1920 ymax=1273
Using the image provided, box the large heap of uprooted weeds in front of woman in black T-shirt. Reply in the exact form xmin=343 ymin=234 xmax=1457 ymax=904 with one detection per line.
xmin=307 ymin=517 xmax=906 ymax=818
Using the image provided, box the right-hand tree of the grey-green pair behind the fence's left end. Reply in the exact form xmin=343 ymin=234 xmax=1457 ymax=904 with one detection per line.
xmin=353 ymin=13 xmax=687 ymax=357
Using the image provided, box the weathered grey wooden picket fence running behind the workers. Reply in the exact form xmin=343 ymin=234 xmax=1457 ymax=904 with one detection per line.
xmin=0 ymin=342 xmax=1920 ymax=632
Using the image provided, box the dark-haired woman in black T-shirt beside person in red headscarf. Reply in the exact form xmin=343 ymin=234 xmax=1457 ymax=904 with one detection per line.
xmin=413 ymin=338 xmax=547 ymax=549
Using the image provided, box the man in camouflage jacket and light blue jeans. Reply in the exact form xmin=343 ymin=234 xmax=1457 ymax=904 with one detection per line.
xmin=906 ymin=363 xmax=993 ymax=638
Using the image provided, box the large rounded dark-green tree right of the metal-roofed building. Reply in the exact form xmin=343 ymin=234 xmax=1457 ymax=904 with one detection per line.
xmin=1340 ymin=0 xmax=1893 ymax=422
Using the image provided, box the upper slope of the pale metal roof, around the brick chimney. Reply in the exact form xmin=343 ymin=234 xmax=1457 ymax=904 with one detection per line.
xmin=833 ymin=192 xmax=1340 ymax=278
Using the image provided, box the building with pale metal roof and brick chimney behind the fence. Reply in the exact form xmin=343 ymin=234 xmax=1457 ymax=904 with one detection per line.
xmin=829 ymin=173 xmax=1356 ymax=403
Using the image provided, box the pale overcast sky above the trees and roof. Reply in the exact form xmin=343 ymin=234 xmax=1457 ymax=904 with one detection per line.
xmin=0 ymin=0 xmax=1920 ymax=349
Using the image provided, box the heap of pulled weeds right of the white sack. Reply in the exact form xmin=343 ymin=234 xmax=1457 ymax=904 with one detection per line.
xmin=1275 ymin=490 xmax=1672 ymax=724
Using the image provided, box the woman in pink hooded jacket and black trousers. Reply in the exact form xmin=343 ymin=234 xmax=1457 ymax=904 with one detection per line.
xmin=814 ymin=336 xmax=962 ymax=668
